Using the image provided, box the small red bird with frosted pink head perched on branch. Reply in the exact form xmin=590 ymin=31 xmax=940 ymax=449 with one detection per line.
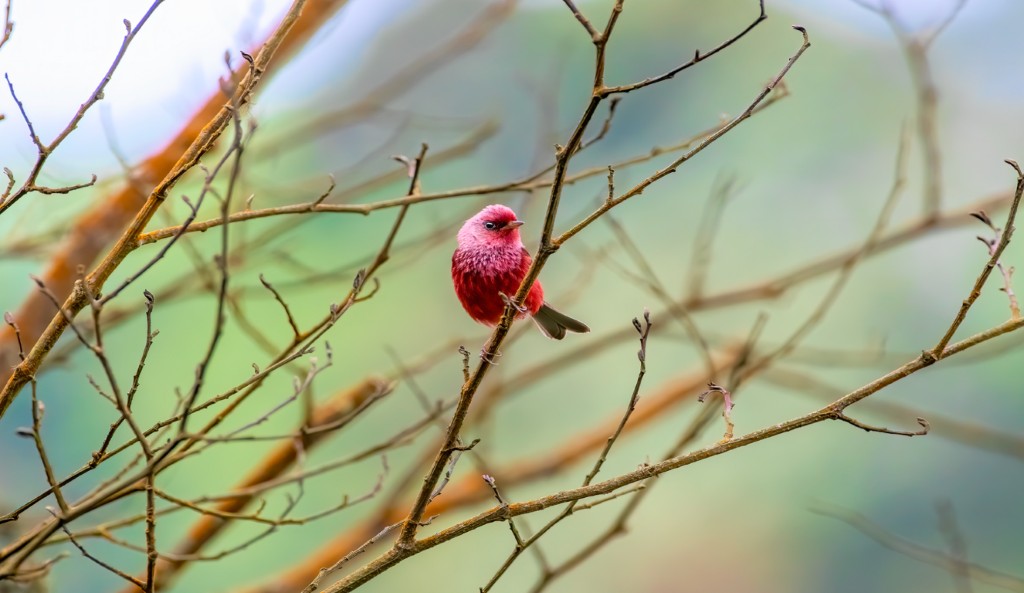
xmin=452 ymin=204 xmax=590 ymax=340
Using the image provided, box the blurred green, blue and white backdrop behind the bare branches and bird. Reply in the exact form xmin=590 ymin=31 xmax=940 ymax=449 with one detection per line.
xmin=0 ymin=0 xmax=1024 ymax=593
